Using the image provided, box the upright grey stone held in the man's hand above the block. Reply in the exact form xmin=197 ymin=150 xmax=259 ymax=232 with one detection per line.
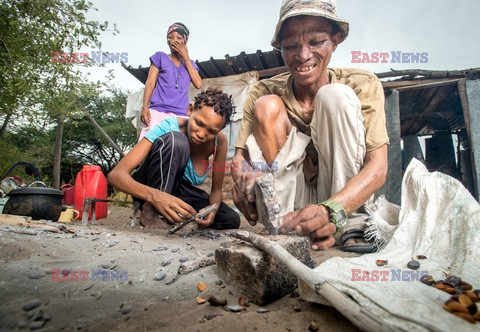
xmin=253 ymin=173 xmax=283 ymax=235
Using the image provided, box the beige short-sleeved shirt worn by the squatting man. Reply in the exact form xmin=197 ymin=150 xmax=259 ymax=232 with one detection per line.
xmin=235 ymin=68 xmax=389 ymax=151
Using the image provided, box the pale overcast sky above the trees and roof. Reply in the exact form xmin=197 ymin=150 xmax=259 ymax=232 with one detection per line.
xmin=85 ymin=0 xmax=480 ymax=92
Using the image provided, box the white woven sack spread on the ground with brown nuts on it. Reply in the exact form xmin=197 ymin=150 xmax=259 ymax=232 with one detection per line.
xmin=299 ymin=159 xmax=480 ymax=331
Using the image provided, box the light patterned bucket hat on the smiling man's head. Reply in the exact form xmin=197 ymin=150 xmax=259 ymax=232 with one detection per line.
xmin=272 ymin=0 xmax=348 ymax=49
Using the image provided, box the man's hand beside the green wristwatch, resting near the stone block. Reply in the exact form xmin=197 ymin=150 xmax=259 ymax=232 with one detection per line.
xmin=280 ymin=204 xmax=337 ymax=250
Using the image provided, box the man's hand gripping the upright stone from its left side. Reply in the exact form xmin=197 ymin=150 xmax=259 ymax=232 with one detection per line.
xmin=233 ymin=171 xmax=263 ymax=226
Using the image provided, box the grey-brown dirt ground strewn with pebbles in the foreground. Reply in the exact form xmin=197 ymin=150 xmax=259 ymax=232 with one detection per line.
xmin=0 ymin=202 xmax=356 ymax=331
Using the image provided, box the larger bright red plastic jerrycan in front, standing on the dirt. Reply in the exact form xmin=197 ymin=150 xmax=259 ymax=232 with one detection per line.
xmin=75 ymin=165 xmax=108 ymax=220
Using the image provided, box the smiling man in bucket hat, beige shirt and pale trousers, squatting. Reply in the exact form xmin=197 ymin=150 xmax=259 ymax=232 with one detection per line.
xmin=232 ymin=0 xmax=389 ymax=252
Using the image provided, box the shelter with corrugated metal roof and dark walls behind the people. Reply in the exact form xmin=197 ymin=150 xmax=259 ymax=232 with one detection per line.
xmin=124 ymin=50 xmax=480 ymax=204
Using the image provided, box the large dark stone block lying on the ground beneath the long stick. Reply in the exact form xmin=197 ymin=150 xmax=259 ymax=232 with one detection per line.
xmin=215 ymin=235 xmax=315 ymax=305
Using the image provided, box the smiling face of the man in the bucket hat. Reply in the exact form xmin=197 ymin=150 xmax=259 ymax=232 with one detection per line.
xmin=280 ymin=16 xmax=339 ymax=86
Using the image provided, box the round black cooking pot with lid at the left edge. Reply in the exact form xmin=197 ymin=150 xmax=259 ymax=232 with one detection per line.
xmin=3 ymin=183 xmax=63 ymax=221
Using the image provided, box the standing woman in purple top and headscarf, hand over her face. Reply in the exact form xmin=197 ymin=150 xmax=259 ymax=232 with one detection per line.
xmin=139 ymin=22 xmax=202 ymax=141
